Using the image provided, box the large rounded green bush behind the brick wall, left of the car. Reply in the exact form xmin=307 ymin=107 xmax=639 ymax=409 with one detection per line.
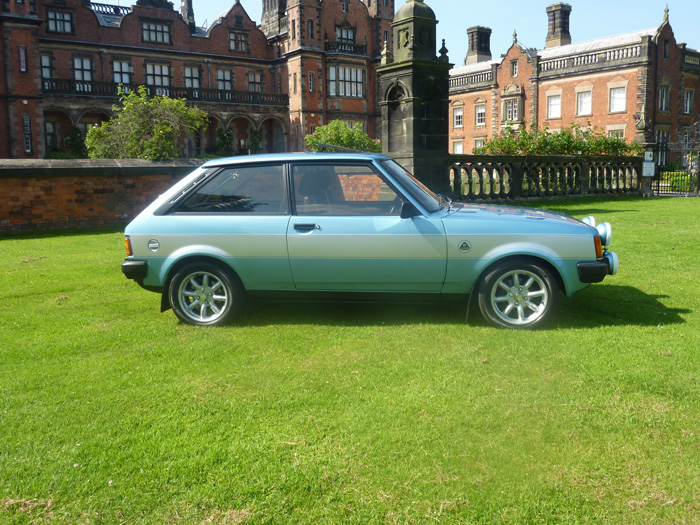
xmin=86 ymin=86 xmax=206 ymax=160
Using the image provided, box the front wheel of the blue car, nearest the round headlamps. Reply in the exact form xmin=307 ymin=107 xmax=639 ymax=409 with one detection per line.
xmin=479 ymin=261 xmax=559 ymax=329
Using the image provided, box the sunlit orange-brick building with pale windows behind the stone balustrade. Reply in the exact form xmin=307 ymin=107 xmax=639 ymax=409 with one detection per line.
xmin=450 ymin=3 xmax=700 ymax=164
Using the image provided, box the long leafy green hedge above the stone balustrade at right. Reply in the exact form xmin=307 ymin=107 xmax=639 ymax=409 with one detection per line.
xmin=474 ymin=124 xmax=642 ymax=156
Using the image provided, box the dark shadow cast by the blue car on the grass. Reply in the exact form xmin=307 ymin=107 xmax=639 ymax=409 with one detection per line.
xmin=236 ymin=285 xmax=692 ymax=329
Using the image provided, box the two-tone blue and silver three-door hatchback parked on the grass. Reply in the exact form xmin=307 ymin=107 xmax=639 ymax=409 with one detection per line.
xmin=122 ymin=153 xmax=618 ymax=328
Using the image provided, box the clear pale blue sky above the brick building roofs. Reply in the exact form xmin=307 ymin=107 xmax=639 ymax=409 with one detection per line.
xmin=189 ymin=0 xmax=700 ymax=66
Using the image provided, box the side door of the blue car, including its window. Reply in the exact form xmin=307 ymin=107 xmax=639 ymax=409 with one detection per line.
xmin=287 ymin=162 xmax=446 ymax=292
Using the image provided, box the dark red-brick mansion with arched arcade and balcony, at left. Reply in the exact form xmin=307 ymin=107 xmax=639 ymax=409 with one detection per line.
xmin=0 ymin=0 xmax=394 ymax=158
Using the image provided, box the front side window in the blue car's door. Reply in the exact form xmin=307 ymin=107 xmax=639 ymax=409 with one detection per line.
xmin=292 ymin=164 xmax=401 ymax=216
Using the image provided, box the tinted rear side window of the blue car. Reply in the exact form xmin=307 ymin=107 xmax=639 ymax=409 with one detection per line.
xmin=175 ymin=164 xmax=287 ymax=215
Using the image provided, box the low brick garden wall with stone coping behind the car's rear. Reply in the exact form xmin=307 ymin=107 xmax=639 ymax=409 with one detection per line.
xmin=0 ymin=159 xmax=201 ymax=233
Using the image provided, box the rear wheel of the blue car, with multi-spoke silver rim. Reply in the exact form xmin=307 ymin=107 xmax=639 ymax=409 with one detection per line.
xmin=168 ymin=263 xmax=244 ymax=326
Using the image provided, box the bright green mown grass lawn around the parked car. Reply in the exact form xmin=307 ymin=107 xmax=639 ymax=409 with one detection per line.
xmin=0 ymin=197 xmax=700 ymax=524
